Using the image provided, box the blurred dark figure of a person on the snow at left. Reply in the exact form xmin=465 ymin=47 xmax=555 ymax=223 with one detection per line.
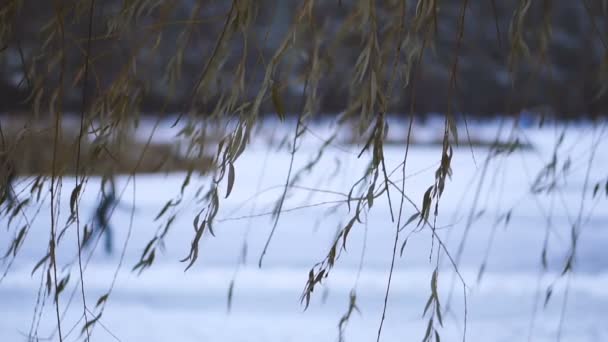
xmin=93 ymin=177 xmax=118 ymax=254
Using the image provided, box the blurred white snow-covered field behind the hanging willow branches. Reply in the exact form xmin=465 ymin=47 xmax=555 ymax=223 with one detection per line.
xmin=0 ymin=118 xmax=608 ymax=342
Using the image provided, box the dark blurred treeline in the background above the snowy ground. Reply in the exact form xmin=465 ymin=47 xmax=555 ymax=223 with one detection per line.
xmin=0 ymin=0 xmax=608 ymax=117
